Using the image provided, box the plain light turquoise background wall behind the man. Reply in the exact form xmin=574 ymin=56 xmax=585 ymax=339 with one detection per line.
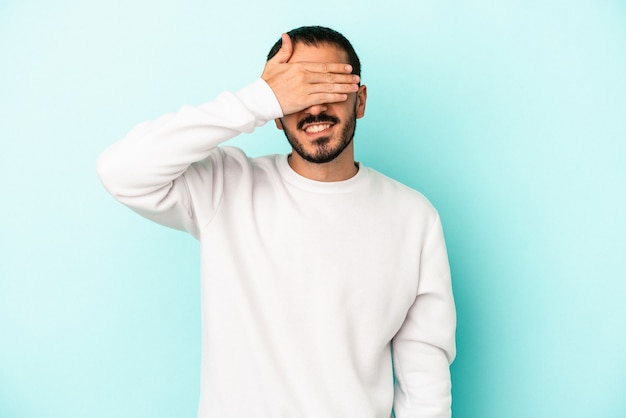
xmin=0 ymin=0 xmax=626 ymax=418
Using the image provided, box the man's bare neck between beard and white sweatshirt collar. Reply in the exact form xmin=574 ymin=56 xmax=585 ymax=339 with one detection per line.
xmin=287 ymin=149 xmax=359 ymax=182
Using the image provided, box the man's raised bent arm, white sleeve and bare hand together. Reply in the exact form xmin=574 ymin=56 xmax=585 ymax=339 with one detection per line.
xmin=97 ymin=34 xmax=358 ymax=235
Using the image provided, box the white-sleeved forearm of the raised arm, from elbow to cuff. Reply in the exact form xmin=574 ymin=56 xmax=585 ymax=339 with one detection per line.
xmin=97 ymin=79 xmax=282 ymax=204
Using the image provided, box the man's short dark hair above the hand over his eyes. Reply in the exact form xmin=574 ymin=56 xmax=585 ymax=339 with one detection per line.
xmin=267 ymin=26 xmax=361 ymax=76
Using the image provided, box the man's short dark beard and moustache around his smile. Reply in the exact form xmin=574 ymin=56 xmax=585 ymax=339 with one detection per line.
xmin=283 ymin=106 xmax=356 ymax=164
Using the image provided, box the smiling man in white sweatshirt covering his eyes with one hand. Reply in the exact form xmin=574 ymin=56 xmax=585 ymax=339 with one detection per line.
xmin=98 ymin=27 xmax=455 ymax=418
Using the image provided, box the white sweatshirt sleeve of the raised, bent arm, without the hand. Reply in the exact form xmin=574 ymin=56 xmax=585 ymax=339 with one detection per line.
xmin=97 ymin=78 xmax=282 ymax=237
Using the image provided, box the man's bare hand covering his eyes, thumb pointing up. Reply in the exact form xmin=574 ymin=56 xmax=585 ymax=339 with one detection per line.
xmin=261 ymin=33 xmax=359 ymax=115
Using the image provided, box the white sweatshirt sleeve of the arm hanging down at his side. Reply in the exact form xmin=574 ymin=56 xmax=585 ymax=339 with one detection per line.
xmin=392 ymin=216 xmax=456 ymax=418
